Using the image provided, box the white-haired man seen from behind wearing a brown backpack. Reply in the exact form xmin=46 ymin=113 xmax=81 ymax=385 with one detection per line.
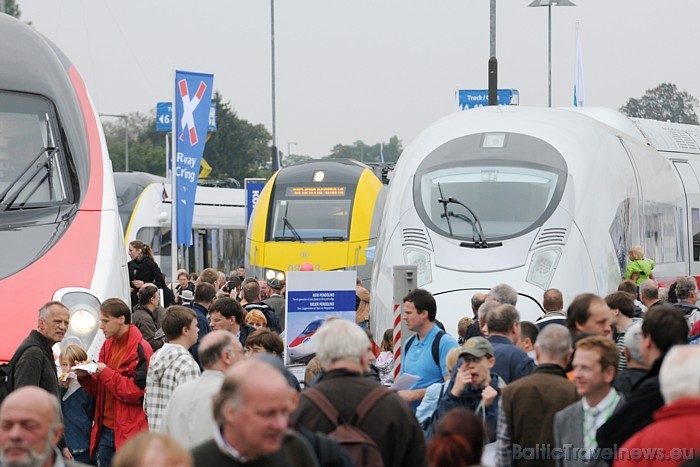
xmin=291 ymin=319 xmax=426 ymax=467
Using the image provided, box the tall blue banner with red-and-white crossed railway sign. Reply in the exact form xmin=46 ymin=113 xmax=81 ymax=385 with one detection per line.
xmin=175 ymin=70 xmax=214 ymax=247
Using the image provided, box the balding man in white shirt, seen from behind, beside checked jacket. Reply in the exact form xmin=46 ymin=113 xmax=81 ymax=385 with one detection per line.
xmin=161 ymin=330 xmax=243 ymax=448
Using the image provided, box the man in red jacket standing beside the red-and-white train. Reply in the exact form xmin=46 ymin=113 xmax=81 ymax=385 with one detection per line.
xmin=77 ymin=298 xmax=153 ymax=467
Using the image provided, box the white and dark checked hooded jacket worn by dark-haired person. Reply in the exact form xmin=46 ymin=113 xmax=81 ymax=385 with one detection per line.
xmin=143 ymin=343 xmax=200 ymax=432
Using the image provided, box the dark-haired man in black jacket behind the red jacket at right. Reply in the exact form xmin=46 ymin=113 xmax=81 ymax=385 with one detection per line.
xmin=596 ymin=305 xmax=688 ymax=462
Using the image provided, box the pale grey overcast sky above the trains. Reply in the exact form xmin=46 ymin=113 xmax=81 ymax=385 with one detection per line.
xmin=17 ymin=0 xmax=700 ymax=157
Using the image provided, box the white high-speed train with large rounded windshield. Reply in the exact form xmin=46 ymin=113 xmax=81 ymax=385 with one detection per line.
xmin=371 ymin=106 xmax=700 ymax=335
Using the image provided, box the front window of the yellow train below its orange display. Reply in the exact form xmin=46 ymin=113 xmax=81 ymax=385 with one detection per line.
xmin=272 ymin=198 xmax=352 ymax=241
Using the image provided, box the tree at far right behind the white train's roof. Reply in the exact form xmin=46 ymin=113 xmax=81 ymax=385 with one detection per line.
xmin=620 ymin=83 xmax=699 ymax=124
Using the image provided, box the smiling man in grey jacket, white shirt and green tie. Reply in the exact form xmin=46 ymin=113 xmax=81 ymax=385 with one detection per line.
xmin=554 ymin=336 xmax=621 ymax=467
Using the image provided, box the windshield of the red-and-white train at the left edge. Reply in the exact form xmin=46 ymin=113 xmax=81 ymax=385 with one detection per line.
xmin=0 ymin=92 xmax=68 ymax=211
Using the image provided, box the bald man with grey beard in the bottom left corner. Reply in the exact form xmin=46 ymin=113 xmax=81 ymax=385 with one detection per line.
xmin=0 ymin=386 xmax=91 ymax=467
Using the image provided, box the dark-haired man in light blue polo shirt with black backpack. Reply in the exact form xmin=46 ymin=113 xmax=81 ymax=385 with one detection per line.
xmin=399 ymin=289 xmax=458 ymax=409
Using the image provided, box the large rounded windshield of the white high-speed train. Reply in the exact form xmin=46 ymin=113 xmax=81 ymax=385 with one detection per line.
xmin=414 ymin=134 xmax=566 ymax=241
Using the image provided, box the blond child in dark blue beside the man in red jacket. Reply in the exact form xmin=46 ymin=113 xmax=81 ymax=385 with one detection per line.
xmin=59 ymin=344 xmax=96 ymax=465
